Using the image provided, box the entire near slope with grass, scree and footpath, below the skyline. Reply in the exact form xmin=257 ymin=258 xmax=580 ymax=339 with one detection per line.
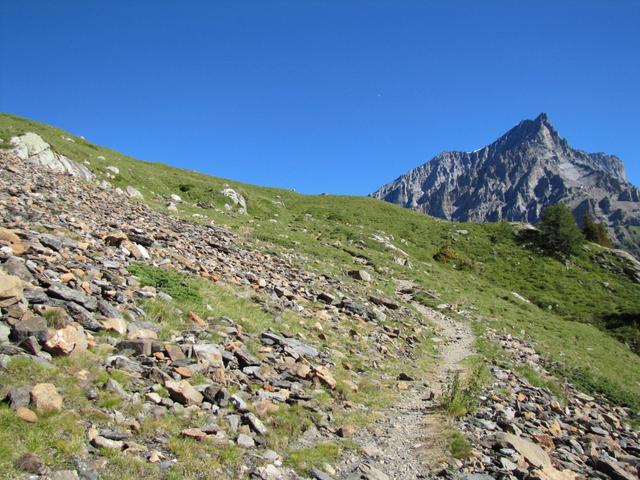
xmin=0 ymin=113 xmax=640 ymax=480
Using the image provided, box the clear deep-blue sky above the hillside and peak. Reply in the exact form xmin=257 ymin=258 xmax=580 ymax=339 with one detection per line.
xmin=0 ymin=0 xmax=640 ymax=195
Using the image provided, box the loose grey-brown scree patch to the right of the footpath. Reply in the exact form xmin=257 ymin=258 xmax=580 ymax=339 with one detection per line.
xmin=459 ymin=334 xmax=640 ymax=480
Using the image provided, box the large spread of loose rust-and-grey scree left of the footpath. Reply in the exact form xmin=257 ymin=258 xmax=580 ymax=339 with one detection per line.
xmin=0 ymin=148 xmax=430 ymax=479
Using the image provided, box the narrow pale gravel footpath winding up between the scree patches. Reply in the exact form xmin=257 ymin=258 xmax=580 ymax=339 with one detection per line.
xmin=336 ymin=290 xmax=474 ymax=480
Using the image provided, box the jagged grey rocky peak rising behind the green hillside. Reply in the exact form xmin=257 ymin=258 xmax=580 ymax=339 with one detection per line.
xmin=372 ymin=113 xmax=640 ymax=252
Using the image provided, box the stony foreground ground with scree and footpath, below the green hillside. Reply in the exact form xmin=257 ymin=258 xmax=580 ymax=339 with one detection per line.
xmin=0 ymin=147 xmax=640 ymax=480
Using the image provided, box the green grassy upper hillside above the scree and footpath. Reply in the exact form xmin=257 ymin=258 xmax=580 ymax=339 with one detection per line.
xmin=0 ymin=114 xmax=640 ymax=408
